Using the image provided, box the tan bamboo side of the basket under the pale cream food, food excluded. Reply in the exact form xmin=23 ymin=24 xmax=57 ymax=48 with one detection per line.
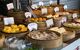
xmin=63 ymin=31 xmax=76 ymax=42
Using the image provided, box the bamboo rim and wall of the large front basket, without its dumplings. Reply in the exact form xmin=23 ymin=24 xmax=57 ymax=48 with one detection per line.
xmin=27 ymin=30 xmax=63 ymax=48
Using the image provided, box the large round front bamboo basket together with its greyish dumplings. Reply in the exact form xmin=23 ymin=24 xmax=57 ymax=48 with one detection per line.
xmin=28 ymin=30 xmax=63 ymax=50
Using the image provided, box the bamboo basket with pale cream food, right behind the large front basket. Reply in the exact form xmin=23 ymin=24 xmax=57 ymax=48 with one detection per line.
xmin=49 ymin=27 xmax=76 ymax=42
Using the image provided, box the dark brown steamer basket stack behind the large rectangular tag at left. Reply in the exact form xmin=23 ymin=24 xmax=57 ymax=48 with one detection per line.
xmin=8 ymin=10 xmax=25 ymax=23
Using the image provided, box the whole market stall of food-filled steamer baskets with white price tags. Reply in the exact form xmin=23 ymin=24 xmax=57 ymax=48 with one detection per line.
xmin=0 ymin=0 xmax=80 ymax=50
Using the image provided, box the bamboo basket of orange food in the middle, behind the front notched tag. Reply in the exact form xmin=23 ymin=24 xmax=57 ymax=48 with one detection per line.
xmin=25 ymin=17 xmax=47 ymax=30
